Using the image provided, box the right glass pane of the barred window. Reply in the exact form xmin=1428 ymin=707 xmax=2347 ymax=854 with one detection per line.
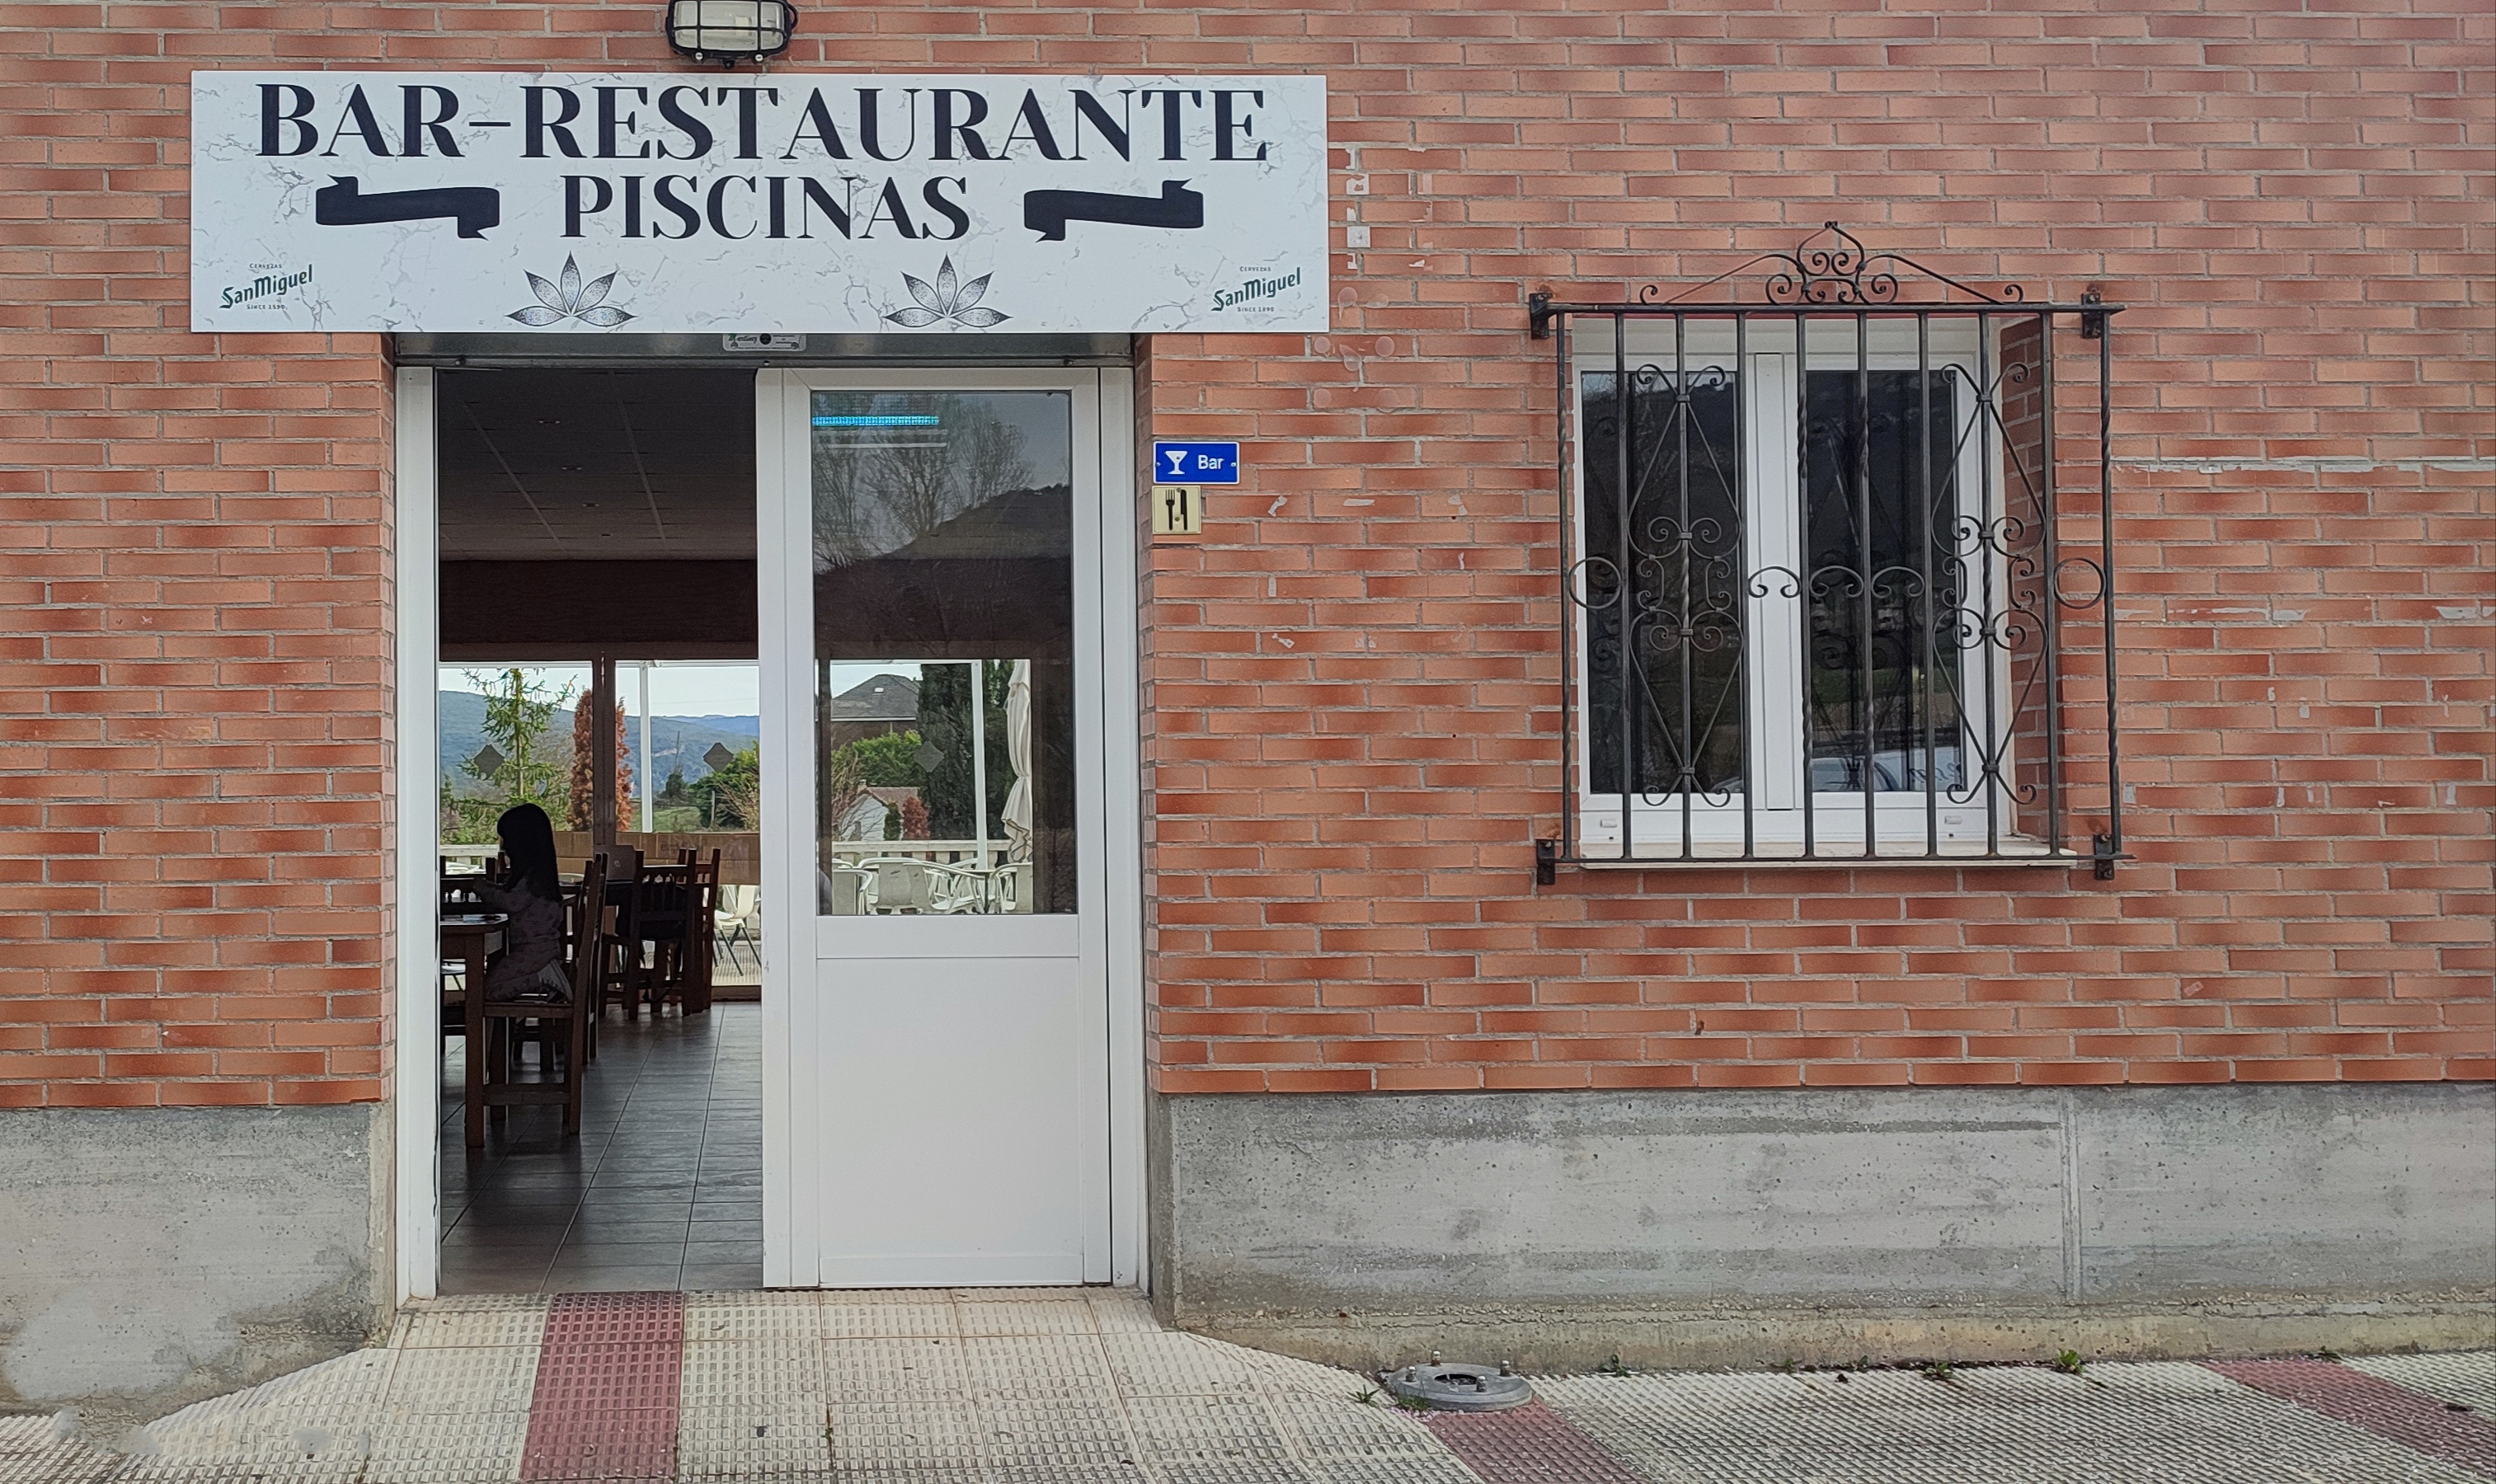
xmin=1805 ymin=369 xmax=1979 ymax=793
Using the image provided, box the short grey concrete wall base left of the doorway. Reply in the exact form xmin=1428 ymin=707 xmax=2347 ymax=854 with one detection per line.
xmin=0 ymin=1105 xmax=392 ymax=1439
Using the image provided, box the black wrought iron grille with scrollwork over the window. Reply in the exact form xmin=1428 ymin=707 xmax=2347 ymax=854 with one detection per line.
xmin=1533 ymin=224 xmax=2124 ymax=878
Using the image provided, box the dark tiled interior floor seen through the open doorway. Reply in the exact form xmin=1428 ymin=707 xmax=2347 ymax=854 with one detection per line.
xmin=442 ymin=1003 xmax=764 ymax=1294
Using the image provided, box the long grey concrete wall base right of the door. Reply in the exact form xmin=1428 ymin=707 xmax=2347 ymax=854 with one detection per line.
xmin=1148 ymin=1082 xmax=2496 ymax=1367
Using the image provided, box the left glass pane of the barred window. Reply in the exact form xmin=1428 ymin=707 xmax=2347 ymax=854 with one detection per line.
xmin=1575 ymin=367 xmax=1745 ymax=801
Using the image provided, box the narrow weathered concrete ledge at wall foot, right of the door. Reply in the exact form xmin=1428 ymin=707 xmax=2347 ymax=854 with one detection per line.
xmin=1178 ymin=1294 xmax=2496 ymax=1372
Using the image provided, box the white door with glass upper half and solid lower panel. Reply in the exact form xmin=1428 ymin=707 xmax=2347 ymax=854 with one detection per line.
xmin=756 ymin=372 xmax=1111 ymax=1287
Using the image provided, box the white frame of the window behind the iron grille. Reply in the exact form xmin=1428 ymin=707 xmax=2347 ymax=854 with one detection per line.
xmin=1568 ymin=314 xmax=2047 ymax=863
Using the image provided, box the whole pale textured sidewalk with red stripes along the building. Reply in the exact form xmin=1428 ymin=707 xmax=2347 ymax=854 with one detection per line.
xmin=0 ymin=1289 xmax=2496 ymax=1484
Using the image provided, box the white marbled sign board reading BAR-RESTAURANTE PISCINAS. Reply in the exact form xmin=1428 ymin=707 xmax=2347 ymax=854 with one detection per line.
xmin=190 ymin=73 xmax=1328 ymax=334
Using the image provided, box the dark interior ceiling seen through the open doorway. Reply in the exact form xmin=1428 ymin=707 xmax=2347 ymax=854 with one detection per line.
xmin=437 ymin=369 xmax=754 ymax=561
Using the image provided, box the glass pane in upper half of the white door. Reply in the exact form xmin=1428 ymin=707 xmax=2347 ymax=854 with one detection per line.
xmin=811 ymin=392 xmax=1076 ymax=915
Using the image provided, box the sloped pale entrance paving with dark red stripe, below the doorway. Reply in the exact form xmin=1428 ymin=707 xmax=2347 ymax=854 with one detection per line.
xmin=102 ymin=1289 xmax=1477 ymax=1484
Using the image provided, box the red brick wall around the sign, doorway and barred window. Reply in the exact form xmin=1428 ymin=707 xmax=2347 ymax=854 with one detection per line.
xmin=0 ymin=0 xmax=2496 ymax=1105
